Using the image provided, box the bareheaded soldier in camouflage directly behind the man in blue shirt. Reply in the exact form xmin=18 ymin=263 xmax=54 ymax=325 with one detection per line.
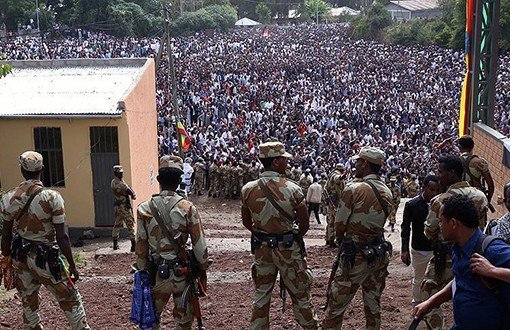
xmin=420 ymin=155 xmax=488 ymax=329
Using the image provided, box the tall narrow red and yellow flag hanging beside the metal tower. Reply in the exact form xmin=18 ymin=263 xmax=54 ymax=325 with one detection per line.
xmin=459 ymin=0 xmax=476 ymax=136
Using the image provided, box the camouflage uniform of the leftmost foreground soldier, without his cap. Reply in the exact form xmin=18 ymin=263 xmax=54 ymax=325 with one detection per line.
xmin=0 ymin=180 xmax=90 ymax=329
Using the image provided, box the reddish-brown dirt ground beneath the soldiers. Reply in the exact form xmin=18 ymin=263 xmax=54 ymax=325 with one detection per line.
xmin=0 ymin=197 xmax=452 ymax=330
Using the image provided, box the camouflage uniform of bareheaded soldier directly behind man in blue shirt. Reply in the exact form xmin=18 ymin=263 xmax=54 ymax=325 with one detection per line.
xmin=420 ymin=181 xmax=488 ymax=329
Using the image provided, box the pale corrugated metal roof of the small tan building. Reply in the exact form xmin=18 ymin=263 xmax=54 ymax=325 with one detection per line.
xmin=0 ymin=60 xmax=145 ymax=118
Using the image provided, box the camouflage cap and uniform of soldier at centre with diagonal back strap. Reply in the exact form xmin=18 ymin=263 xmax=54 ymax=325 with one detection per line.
xmin=241 ymin=142 xmax=317 ymax=330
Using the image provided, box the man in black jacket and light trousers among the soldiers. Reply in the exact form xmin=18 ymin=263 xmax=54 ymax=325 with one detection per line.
xmin=400 ymin=175 xmax=439 ymax=304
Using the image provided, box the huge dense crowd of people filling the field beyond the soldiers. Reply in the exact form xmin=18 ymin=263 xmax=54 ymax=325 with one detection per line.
xmin=0 ymin=25 xmax=510 ymax=192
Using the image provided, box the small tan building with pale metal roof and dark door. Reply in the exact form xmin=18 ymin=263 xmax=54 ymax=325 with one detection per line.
xmin=0 ymin=59 xmax=158 ymax=230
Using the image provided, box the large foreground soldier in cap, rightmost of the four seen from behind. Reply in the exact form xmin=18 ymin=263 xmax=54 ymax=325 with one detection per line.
xmin=322 ymin=147 xmax=393 ymax=329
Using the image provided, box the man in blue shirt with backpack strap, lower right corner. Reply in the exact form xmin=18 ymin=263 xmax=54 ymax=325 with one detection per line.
xmin=413 ymin=195 xmax=510 ymax=330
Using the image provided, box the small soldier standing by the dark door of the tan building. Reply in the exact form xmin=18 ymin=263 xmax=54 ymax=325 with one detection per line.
xmin=111 ymin=165 xmax=136 ymax=252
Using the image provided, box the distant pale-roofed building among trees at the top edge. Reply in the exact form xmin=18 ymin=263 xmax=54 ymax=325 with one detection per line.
xmin=386 ymin=0 xmax=443 ymax=21
